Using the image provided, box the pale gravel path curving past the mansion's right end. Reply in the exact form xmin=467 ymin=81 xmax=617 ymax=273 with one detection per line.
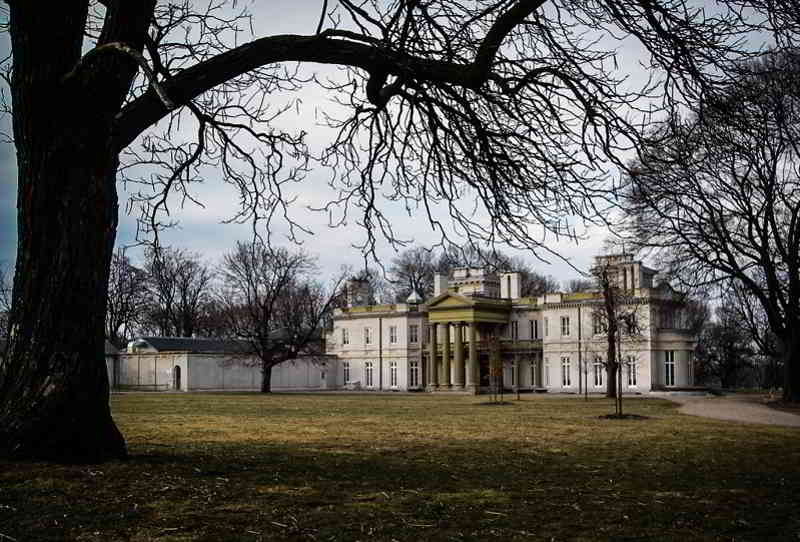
xmin=665 ymin=395 xmax=800 ymax=427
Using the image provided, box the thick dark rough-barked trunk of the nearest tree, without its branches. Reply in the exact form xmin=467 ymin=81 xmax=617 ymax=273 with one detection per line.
xmin=0 ymin=2 xmax=130 ymax=463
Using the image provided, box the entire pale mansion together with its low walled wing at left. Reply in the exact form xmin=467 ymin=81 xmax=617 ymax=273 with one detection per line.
xmin=107 ymin=254 xmax=695 ymax=393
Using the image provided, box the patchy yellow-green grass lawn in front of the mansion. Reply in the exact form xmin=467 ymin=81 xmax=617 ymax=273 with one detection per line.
xmin=0 ymin=394 xmax=800 ymax=542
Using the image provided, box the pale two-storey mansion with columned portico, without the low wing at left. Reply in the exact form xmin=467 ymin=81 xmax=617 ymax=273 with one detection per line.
xmin=326 ymin=254 xmax=695 ymax=393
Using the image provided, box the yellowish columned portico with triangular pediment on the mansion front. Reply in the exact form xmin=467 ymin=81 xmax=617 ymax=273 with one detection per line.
xmin=426 ymin=292 xmax=511 ymax=393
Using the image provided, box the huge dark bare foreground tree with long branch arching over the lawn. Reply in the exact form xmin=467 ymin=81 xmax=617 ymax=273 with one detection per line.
xmin=0 ymin=0 xmax=735 ymax=461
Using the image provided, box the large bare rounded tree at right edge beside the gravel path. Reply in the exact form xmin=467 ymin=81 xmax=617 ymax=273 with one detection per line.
xmin=627 ymin=51 xmax=800 ymax=401
